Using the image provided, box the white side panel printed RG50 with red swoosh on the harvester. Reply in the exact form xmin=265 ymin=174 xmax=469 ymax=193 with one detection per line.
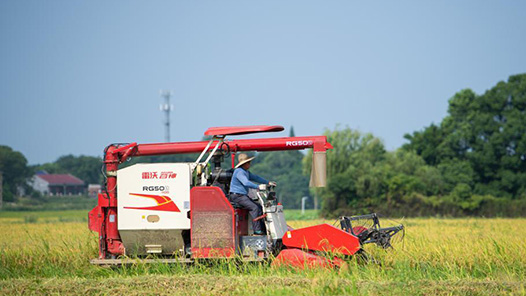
xmin=117 ymin=163 xmax=191 ymax=230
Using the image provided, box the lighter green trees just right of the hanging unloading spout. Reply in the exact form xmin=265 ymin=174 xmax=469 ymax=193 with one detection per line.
xmin=304 ymin=128 xmax=445 ymax=217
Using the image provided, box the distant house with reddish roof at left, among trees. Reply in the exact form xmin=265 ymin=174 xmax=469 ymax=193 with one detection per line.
xmin=30 ymin=172 xmax=86 ymax=195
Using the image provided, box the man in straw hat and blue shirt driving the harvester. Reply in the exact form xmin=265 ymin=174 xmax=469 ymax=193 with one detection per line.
xmin=230 ymin=153 xmax=276 ymax=235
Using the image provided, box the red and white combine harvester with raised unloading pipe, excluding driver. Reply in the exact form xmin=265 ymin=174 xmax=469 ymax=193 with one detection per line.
xmin=88 ymin=126 xmax=403 ymax=268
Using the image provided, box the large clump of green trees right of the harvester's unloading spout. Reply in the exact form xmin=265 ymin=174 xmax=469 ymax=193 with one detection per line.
xmin=310 ymin=74 xmax=526 ymax=216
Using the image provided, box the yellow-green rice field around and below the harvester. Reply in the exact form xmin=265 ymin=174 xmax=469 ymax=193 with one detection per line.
xmin=0 ymin=211 xmax=526 ymax=295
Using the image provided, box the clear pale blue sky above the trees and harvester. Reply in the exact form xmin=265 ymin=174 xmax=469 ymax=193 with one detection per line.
xmin=0 ymin=0 xmax=526 ymax=164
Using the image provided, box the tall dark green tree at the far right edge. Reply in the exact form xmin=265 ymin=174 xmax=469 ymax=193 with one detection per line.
xmin=404 ymin=74 xmax=526 ymax=198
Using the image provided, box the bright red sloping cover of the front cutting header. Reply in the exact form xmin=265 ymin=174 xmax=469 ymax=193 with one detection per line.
xmin=283 ymin=224 xmax=360 ymax=255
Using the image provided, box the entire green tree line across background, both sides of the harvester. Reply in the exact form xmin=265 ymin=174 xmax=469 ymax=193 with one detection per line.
xmin=0 ymin=74 xmax=526 ymax=217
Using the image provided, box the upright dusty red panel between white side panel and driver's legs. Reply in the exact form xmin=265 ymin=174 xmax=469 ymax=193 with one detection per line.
xmin=190 ymin=186 xmax=236 ymax=258
